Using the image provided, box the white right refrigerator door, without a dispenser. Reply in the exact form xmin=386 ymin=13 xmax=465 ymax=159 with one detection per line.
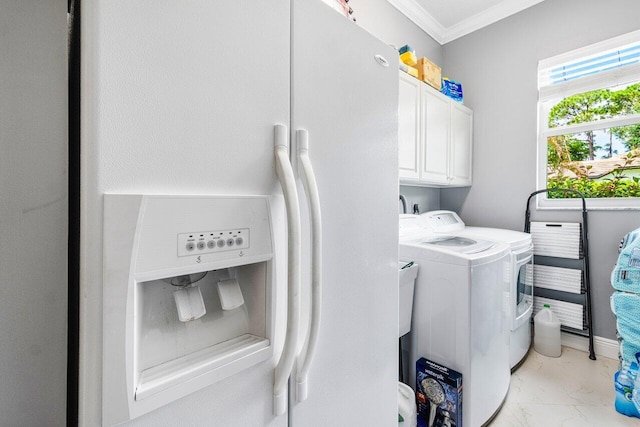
xmin=290 ymin=1 xmax=398 ymax=427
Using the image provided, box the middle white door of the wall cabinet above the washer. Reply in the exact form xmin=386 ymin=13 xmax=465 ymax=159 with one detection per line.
xmin=420 ymin=85 xmax=451 ymax=185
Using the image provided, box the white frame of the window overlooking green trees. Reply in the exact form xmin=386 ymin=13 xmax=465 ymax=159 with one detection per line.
xmin=536 ymin=30 xmax=640 ymax=210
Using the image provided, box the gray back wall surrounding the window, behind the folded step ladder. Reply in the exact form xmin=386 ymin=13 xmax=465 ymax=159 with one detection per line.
xmin=440 ymin=0 xmax=640 ymax=339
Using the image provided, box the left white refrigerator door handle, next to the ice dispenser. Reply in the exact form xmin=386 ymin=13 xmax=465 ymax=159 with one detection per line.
xmin=273 ymin=124 xmax=301 ymax=415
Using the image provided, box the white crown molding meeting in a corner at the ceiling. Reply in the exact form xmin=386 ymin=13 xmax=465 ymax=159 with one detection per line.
xmin=387 ymin=0 xmax=544 ymax=45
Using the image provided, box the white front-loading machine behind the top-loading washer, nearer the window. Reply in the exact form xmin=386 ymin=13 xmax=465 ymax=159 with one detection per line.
xmin=422 ymin=211 xmax=533 ymax=369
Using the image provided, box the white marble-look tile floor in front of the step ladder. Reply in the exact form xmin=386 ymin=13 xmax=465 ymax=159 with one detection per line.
xmin=490 ymin=347 xmax=640 ymax=427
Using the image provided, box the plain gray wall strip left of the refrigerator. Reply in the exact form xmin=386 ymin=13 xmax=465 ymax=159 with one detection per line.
xmin=0 ymin=0 xmax=67 ymax=426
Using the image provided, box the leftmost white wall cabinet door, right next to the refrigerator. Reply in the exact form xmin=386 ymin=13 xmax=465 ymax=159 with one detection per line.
xmin=398 ymin=71 xmax=420 ymax=183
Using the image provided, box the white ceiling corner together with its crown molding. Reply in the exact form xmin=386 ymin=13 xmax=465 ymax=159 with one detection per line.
xmin=387 ymin=0 xmax=544 ymax=44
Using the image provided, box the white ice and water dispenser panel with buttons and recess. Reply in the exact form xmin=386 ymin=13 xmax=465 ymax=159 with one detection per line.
xmin=103 ymin=194 xmax=276 ymax=425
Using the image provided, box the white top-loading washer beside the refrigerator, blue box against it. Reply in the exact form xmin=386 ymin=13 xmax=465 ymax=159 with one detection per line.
xmin=399 ymin=215 xmax=511 ymax=426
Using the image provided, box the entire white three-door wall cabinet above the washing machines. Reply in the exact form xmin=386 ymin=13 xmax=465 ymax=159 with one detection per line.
xmin=398 ymin=71 xmax=473 ymax=187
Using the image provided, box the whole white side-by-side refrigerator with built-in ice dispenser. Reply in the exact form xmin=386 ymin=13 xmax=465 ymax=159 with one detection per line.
xmin=77 ymin=0 xmax=398 ymax=427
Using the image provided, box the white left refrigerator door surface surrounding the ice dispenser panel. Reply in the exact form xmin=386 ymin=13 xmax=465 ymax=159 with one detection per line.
xmin=79 ymin=0 xmax=290 ymax=426
